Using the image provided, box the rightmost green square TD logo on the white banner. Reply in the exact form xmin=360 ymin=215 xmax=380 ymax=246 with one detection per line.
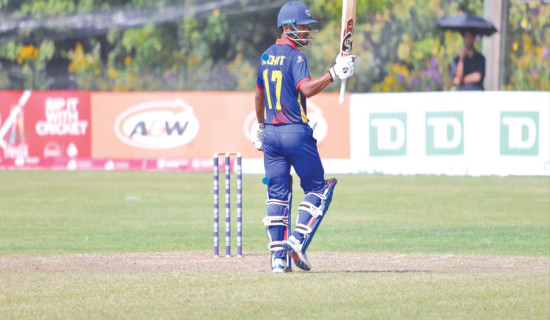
xmin=500 ymin=111 xmax=539 ymax=156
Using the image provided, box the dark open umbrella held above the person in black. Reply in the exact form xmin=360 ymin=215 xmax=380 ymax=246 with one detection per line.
xmin=435 ymin=12 xmax=497 ymax=36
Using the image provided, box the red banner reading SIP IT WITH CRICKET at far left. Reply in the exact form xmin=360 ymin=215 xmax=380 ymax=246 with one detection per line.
xmin=0 ymin=91 xmax=91 ymax=166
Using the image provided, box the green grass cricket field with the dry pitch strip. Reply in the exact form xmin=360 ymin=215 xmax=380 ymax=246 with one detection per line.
xmin=0 ymin=171 xmax=550 ymax=319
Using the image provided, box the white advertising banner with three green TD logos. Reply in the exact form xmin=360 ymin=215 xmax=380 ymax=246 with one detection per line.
xmin=350 ymin=91 xmax=550 ymax=176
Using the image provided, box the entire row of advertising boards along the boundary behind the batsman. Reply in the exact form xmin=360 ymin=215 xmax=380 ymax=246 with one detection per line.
xmin=0 ymin=91 xmax=550 ymax=176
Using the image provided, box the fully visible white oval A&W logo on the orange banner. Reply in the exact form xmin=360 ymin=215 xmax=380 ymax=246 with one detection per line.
xmin=114 ymin=99 xmax=199 ymax=149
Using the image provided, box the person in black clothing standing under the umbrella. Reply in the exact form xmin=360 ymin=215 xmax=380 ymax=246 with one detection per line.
xmin=452 ymin=31 xmax=485 ymax=90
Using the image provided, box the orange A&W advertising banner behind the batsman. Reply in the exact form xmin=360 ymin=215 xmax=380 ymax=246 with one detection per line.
xmin=92 ymin=92 xmax=350 ymax=159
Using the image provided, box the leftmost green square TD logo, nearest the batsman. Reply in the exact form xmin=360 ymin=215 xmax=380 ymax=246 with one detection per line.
xmin=369 ymin=112 xmax=407 ymax=157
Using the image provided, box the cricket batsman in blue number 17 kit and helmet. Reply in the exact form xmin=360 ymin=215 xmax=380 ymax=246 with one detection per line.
xmin=253 ymin=1 xmax=355 ymax=273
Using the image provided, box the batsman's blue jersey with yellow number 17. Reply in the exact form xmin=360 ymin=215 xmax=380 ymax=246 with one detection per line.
xmin=256 ymin=39 xmax=311 ymax=124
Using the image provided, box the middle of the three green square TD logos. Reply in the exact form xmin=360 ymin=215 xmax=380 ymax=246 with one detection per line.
xmin=426 ymin=111 xmax=464 ymax=155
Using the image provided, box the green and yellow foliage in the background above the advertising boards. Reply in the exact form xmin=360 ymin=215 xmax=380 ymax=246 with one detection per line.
xmin=0 ymin=0 xmax=550 ymax=92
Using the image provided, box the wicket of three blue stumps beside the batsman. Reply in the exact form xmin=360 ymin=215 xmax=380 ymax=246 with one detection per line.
xmin=212 ymin=152 xmax=243 ymax=258
